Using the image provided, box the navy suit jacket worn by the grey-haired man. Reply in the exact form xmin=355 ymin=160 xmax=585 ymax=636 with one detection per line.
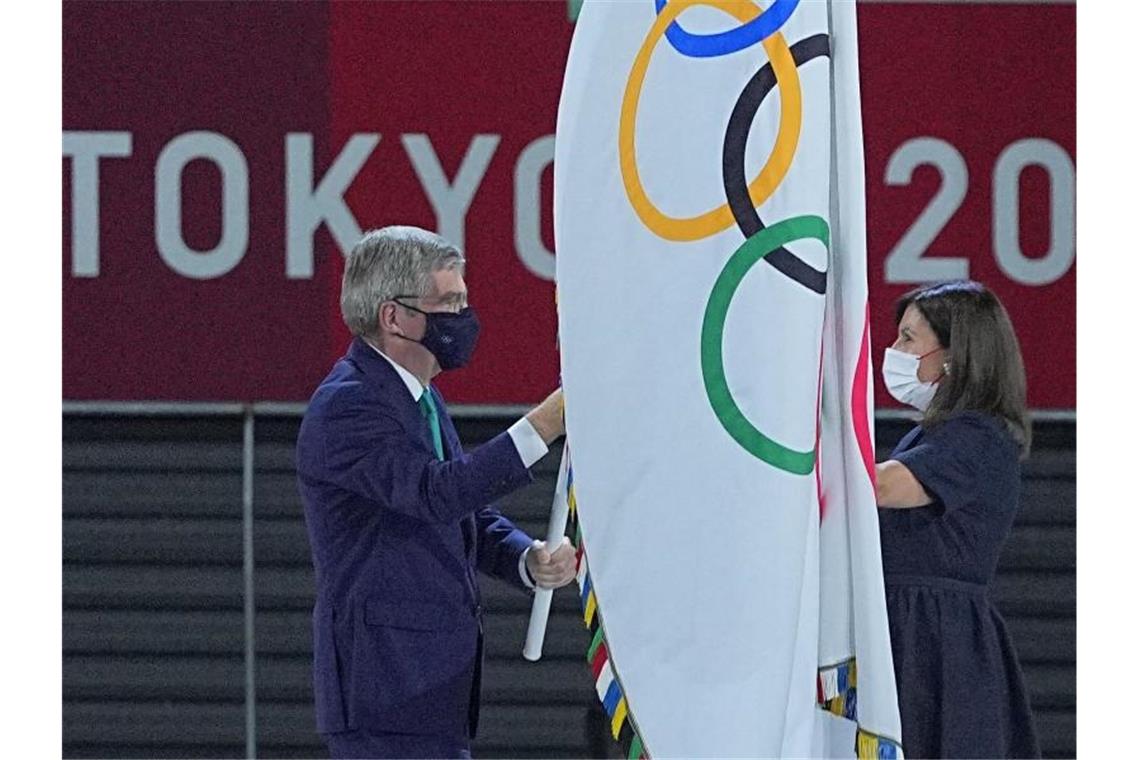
xmin=296 ymin=338 xmax=531 ymax=736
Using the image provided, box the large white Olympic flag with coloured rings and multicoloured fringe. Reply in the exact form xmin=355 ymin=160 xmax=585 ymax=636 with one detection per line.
xmin=554 ymin=0 xmax=902 ymax=757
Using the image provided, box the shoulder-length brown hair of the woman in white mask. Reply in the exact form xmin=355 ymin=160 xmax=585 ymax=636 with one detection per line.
xmin=895 ymin=280 xmax=1032 ymax=458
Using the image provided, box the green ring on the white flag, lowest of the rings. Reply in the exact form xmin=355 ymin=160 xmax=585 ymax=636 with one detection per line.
xmin=701 ymin=215 xmax=831 ymax=475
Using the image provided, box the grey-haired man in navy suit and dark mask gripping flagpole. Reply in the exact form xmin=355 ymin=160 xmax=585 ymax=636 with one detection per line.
xmin=296 ymin=227 xmax=575 ymax=758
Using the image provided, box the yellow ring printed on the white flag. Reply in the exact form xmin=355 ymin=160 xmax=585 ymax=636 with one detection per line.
xmin=618 ymin=0 xmax=803 ymax=240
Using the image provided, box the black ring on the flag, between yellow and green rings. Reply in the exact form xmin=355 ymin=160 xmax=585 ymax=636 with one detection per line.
xmin=722 ymin=34 xmax=831 ymax=295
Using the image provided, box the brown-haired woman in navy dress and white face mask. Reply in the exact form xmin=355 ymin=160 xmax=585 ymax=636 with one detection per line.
xmin=877 ymin=281 xmax=1041 ymax=759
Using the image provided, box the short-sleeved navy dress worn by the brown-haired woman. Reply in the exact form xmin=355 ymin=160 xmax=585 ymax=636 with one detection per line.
xmin=879 ymin=412 xmax=1041 ymax=759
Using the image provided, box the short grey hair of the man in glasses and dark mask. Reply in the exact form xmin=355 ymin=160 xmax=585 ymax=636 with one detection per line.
xmin=341 ymin=226 xmax=465 ymax=337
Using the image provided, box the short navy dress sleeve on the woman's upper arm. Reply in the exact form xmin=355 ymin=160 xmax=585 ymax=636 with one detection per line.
xmin=893 ymin=415 xmax=1003 ymax=512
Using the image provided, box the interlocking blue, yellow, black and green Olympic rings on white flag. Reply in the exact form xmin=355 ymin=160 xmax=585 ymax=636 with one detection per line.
xmin=618 ymin=0 xmax=831 ymax=475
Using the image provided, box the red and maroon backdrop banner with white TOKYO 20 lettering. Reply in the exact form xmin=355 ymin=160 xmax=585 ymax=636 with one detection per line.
xmin=63 ymin=0 xmax=1076 ymax=408
